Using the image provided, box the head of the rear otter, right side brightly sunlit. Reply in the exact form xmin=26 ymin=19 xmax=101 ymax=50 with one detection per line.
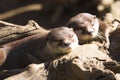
xmin=67 ymin=13 xmax=99 ymax=41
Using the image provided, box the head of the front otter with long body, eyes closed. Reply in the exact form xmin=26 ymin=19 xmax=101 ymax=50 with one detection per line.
xmin=47 ymin=27 xmax=78 ymax=53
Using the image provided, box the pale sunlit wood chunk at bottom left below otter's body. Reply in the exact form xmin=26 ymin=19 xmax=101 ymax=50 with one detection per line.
xmin=0 ymin=63 xmax=48 ymax=80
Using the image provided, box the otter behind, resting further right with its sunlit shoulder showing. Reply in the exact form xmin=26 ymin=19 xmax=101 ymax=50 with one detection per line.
xmin=66 ymin=13 xmax=116 ymax=48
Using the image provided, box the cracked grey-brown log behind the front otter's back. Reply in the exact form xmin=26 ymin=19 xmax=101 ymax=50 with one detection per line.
xmin=0 ymin=20 xmax=45 ymax=45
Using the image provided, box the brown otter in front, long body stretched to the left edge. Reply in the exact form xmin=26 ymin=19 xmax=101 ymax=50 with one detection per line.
xmin=0 ymin=26 xmax=78 ymax=70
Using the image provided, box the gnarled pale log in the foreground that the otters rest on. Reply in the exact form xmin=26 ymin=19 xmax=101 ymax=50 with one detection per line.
xmin=0 ymin=44 xmax=120 ymax=80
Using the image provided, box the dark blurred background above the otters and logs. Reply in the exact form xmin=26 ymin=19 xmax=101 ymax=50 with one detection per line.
xmin=0 ymin=0 xmax=120 ymax=28
